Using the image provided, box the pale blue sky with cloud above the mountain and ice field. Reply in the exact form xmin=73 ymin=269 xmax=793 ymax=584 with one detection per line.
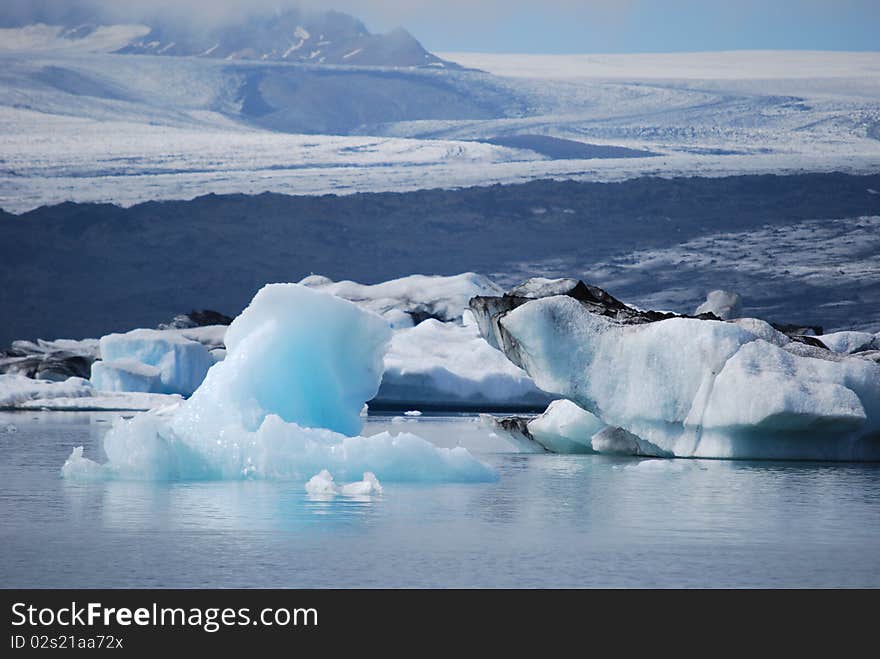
xmin=0 ymin=0 xmax=880 ymax=53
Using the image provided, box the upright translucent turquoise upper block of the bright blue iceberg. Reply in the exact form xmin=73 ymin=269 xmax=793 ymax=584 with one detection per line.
xmin=174 ymin=284 xmax=391 ymax=435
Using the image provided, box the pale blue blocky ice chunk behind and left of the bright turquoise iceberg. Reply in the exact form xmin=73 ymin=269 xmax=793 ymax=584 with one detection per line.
xmin=92 ymin=329 xmax=214 ymax=396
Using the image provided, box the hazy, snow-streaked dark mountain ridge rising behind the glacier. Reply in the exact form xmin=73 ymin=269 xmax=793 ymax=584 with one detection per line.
xmin=0 ymin=0 xmax=455 ymax=68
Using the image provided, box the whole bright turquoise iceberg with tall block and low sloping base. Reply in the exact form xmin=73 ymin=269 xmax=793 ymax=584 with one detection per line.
xmin=62 ymin=284 xmax=496 ymax=482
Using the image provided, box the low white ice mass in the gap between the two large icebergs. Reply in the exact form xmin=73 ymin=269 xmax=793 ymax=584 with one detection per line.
xmin=376 ymin=320 xmax=551 ymax=409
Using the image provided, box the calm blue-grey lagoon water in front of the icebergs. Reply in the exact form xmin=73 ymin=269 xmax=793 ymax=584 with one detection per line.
xmin=0 ymin=412 xmax=880 ymax=588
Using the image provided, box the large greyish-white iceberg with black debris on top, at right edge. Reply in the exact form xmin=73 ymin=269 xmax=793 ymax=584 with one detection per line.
xmin=472 ymin=285 xmax=880 ymax=460
